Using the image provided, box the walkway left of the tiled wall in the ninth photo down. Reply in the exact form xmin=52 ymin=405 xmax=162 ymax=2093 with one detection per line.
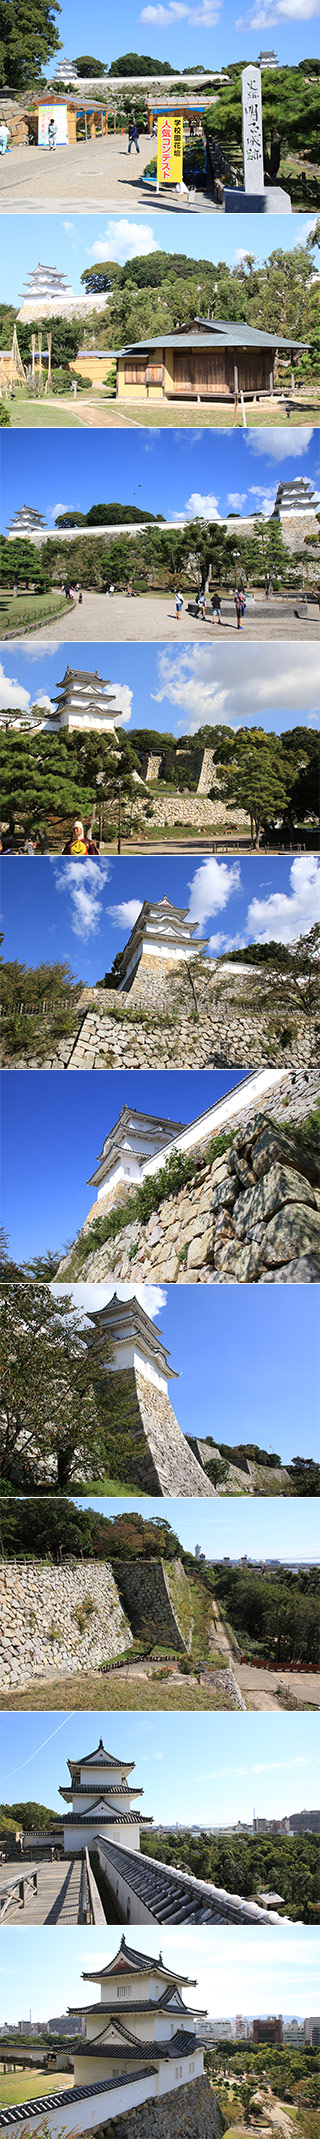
xmin=0 ymin=1857 xmax=83 ymax=1927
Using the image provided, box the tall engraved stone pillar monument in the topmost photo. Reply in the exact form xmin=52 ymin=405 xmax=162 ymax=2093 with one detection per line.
xmin=224 ymin=66 xmax=290 ymax=216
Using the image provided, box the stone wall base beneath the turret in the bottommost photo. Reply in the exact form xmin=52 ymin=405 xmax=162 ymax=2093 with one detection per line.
xmin=100 ymin=2075 xmax=226 ymax=2139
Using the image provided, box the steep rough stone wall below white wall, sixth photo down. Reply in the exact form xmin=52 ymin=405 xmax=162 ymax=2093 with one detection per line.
xmin=58 ymin=1070 xmax=320 ymax=1286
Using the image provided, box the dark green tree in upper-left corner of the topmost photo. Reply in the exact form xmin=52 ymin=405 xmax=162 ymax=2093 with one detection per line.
xmin=0 ymin=0 xmax=62 ymax=94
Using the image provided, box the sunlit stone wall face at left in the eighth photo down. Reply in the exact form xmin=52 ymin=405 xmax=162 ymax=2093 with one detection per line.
xmin=0 ymin=1559 xmax=132 ymax=1688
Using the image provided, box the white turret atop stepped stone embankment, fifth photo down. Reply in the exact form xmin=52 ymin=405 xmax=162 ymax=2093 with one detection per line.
xmin=117 ymin=896 xmax=205 ymax=992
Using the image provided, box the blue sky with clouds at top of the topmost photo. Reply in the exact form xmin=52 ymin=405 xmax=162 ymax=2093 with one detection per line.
xmin=45 ymin=0 xmax=318 ymax=73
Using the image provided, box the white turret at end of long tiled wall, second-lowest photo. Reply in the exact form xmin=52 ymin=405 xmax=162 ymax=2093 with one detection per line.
xmin=60 ymin=1739 xmax=151 ymax=1857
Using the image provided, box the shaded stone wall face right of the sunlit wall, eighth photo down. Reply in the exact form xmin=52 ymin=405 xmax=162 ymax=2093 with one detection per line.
xmin=117 ymin=1559 xmax=192 ymax=1653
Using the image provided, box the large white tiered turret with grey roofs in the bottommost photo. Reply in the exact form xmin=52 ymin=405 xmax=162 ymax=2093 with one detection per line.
xmin=73 ymin=1936 xmax=205 ymax=2107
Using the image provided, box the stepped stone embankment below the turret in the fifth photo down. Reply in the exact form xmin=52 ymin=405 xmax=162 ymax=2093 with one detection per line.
xmin=2 ymin=956 xmax=316 ymax=1070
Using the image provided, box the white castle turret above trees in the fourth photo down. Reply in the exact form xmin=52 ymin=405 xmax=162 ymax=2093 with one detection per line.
xmin=49 ymin=667 xmax=126 ymax=736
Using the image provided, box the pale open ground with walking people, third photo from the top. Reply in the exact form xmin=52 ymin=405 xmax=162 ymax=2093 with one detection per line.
xmin=23 ymin=593 xmax=320 ymax=645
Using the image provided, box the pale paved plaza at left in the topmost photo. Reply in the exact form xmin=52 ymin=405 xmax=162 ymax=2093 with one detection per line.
xmin=0 ymin=135 xmax=212 ymax=216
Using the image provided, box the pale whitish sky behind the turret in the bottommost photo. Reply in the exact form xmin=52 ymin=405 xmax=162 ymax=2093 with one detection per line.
xmin=0 ymin=1925 xmax=318 ymax=2019
